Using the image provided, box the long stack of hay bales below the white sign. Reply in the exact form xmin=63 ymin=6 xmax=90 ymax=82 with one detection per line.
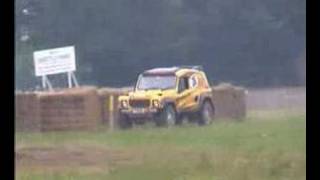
xmin=15 ymin=87 xmax=101 ymax=131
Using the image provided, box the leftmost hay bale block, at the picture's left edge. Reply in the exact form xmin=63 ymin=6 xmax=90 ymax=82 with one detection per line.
xmin=15 ymin=92 xmax=41 ymax=131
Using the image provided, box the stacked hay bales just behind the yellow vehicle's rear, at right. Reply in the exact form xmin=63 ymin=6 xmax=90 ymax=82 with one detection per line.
xmin=212 ymin=83 xmax=246 ymax=120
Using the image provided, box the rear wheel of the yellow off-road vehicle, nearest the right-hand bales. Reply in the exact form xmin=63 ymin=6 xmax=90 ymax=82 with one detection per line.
xmin=198 ymin=100 xmax=214 ymax=126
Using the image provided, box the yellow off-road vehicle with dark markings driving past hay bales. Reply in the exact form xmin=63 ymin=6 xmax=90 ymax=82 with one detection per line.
xmin=118 ymin=66 xmax=214 ymax=128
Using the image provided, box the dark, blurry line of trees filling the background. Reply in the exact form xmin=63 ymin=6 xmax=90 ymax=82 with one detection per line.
xmin=15 ymin=0 xmax=306 ymax=89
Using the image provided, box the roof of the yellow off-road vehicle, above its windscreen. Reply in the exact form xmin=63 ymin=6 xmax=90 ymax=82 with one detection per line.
xmin=143 ymin=67 xmax=200 ymax=76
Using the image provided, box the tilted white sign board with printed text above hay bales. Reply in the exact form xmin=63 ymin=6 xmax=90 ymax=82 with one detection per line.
xmin=33 ymin=46 xmax=76 ymax=76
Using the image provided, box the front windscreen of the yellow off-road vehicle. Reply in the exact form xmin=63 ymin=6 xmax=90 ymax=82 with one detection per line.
xmin=137 ymin=75 xmax=176 ymax=90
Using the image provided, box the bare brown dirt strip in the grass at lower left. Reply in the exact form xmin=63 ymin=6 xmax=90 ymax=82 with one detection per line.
xmin=15 ymin=145 xmax=141 ymax=171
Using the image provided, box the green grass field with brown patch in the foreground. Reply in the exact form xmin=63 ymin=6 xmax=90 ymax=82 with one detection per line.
xmin=15 ymin=111 xmax=306 ymax=180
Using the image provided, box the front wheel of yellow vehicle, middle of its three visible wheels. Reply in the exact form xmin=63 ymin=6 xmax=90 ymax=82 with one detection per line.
xmin=155 ymin=105 xmax=177 ymax=127
